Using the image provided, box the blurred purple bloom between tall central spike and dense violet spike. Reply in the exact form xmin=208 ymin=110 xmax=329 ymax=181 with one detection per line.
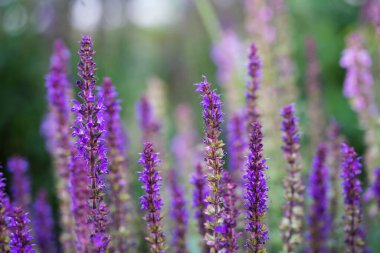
xmin=228 ymin=113 xmax=246 ymax=182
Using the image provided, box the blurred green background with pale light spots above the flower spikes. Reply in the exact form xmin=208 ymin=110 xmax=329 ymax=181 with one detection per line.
xmin=0 ymin=0 xmax=378 ymax=252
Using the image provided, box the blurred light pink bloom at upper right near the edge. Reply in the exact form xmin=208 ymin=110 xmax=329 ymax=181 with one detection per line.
xmin=340 ymin=33 xmax=373 ymax=112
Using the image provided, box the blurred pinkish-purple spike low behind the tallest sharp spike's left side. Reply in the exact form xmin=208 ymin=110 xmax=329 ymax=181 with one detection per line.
xmin=69 ymin=151 xmax=93 ymax=253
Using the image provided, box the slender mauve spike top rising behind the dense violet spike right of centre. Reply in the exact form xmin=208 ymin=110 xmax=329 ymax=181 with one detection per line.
xmin=245 ymin=43 xmax=261 ymax=133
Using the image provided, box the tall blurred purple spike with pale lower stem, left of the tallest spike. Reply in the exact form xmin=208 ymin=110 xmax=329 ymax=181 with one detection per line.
xmin=43 ymin=40 xmax=74 ymax=251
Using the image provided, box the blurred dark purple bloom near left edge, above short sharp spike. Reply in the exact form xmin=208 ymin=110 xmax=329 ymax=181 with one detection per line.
xmin=7 ymin=156 xmax=31 ymax=210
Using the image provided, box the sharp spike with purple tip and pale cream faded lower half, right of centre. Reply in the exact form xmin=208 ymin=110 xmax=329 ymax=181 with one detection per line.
xmin=280 ymin=105 xmax=304 ymax=252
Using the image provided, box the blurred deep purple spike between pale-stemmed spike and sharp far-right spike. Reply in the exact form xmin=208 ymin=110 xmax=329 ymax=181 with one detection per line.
xmin=309 ymin=143 xmax=330 ymax=253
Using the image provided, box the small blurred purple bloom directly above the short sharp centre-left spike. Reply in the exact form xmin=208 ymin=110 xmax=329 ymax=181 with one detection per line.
xmin=136 ymin=96 xmax=161 ymax=141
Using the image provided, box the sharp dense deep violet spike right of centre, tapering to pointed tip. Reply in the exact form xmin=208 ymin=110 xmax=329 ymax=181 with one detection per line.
xmin=244 ymin=121 xmax=269 ymax=252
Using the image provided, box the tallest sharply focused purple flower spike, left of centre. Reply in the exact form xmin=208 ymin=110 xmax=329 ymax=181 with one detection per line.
xmin=72 ymin=35 xmax=110 ymax=252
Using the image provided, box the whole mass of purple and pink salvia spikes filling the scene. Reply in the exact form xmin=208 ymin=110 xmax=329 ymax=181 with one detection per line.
xmin=0 ymin=16 xmax=380 ymax=253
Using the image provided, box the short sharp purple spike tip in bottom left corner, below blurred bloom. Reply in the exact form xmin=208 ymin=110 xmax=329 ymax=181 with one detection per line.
xmin=7 ymin=207 xmax=34 ymax=253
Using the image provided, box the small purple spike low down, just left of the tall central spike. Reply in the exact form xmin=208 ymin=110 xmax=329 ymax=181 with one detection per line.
xmin=191 ymin=163 xmax=209 ymax=253
